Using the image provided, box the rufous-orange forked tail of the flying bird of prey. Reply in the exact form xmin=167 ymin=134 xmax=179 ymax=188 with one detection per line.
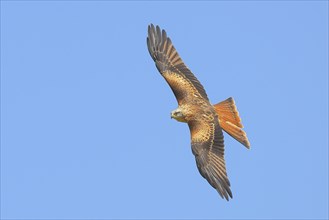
xmin=214 ymin=97 xmax=250 ymax=149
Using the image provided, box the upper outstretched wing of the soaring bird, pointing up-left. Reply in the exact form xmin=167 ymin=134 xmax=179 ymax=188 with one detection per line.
xmin=147 ymin=24 xmax=208 ymax=104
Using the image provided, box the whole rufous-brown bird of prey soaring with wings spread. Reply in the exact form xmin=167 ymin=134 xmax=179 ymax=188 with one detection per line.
xmin=147 ymin=24 xmax=250 ymax=201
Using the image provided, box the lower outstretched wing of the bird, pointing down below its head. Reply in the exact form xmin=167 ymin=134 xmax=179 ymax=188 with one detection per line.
xmin=188 ymin=113 xmax=232 ymax=200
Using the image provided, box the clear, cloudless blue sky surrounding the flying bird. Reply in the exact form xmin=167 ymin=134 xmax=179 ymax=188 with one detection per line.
xmin=1 ymin=1 xmax=328 ymax=219
